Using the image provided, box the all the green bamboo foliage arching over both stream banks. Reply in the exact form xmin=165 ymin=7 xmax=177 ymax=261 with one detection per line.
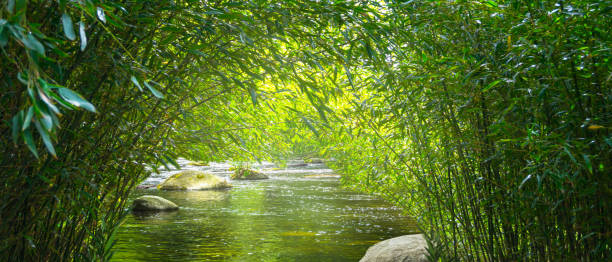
xmin=0 ymin=0 xmax=612 ymax=261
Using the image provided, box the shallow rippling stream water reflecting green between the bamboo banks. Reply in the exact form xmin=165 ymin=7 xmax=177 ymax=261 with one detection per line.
xmin=113 ymin=160 xmax=417 ymax=261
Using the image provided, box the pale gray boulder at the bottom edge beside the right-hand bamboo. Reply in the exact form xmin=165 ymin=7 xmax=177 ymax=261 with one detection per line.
xmin=359 ymin=234 xmax=427 ymax=262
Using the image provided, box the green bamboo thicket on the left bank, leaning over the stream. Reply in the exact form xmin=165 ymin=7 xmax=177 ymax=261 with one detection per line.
xmin=0 ymin=0 xmax=378 ymax=261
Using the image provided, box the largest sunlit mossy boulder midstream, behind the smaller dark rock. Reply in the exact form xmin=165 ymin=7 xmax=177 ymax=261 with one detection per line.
xmin=157 ymin=170 xmax=232 ymax=190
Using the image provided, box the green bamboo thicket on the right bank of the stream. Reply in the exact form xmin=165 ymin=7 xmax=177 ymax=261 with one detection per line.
xmin=318 ymin=1 xmax=612 ymax=261
